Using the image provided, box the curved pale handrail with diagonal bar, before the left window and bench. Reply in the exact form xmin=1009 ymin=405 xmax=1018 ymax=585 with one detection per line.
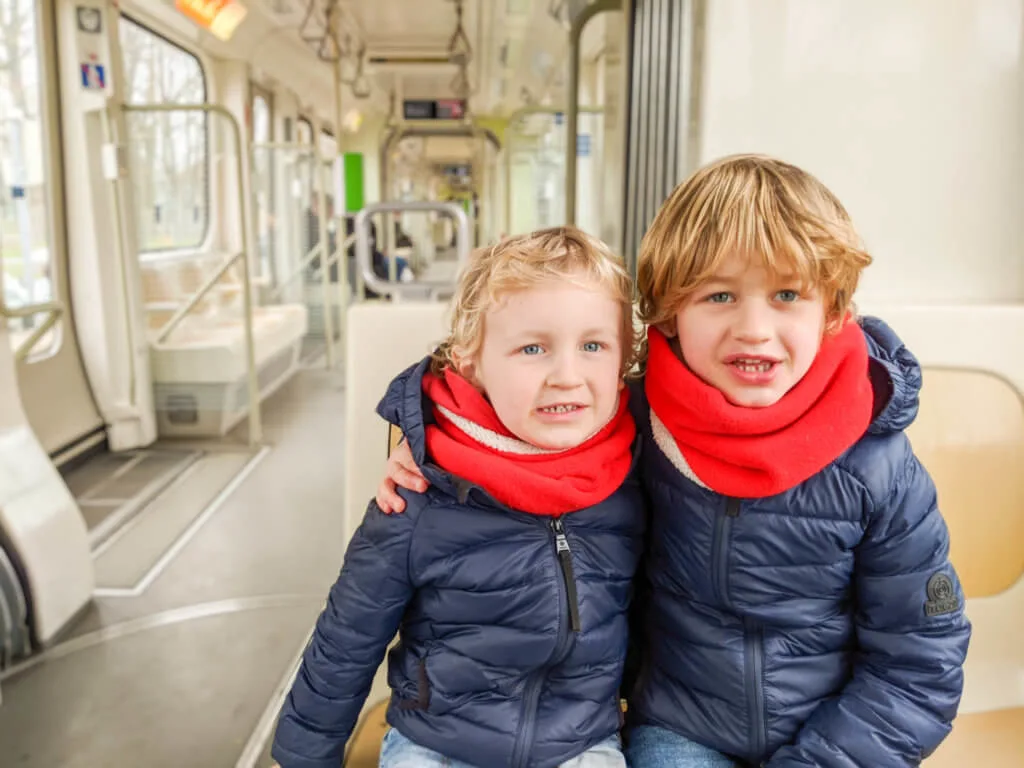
xmin=121 ymin=103 xmax=263 ymax=444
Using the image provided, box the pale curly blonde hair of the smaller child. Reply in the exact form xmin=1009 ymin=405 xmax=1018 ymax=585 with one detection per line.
xmin=431 ymin=226 xmax=639 ymax=375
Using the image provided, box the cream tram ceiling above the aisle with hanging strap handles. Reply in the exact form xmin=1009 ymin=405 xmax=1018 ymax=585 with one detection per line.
xmin=240 ymin=0 xmax=593 ymax=115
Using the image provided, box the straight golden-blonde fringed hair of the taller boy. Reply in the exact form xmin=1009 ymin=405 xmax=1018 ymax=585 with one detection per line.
xmin=637 ymin=155 xmax=871 ymax=330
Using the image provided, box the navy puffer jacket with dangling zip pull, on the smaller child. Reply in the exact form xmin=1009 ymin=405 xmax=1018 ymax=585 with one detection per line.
xmin=272 ymin=360 xmax=645 ymax=768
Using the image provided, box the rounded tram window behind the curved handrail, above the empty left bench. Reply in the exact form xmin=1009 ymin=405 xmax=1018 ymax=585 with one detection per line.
xmin=120 ymin=16 xmax=210 ymax=253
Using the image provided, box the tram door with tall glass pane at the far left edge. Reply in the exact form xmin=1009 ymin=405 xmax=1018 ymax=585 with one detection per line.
xmin=0 ymin=0 xmax=103 ymax=456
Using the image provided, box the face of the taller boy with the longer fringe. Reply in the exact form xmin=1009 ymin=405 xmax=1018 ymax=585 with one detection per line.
xmin=676 ymin=254 xmax=825 ymax=408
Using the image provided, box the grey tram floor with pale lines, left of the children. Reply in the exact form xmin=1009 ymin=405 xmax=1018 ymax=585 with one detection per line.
xmin=0 ymin=368 xmax=354 ymax=768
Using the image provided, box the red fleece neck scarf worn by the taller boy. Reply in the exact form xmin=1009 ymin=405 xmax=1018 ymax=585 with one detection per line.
xmin=645 ymin=323 xmax=873 ymax=499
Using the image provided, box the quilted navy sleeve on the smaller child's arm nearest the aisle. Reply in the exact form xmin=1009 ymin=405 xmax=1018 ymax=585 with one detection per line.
xmin=271 ymin=494 xmax=425 ymax=768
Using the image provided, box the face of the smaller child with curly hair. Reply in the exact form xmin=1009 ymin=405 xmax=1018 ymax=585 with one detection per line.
xmin=463 ymin=283 xmax=623 ymax=451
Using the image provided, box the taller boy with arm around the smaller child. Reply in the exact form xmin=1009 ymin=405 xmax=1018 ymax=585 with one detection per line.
xmin=379 ymin=155 xmax=971 ymax=768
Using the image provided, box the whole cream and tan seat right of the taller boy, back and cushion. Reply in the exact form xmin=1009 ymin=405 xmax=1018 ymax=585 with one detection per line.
xmin=864 ymin=306 xmax=1024 ymax=768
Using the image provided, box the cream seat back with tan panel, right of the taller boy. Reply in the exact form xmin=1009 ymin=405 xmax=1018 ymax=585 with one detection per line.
xmin=862 ymin=306 xmax=1024 ymax=598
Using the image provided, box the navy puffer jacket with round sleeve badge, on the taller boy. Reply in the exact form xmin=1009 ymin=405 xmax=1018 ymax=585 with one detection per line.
xmin=630 ymin=318 xmax=971 ymax=768
